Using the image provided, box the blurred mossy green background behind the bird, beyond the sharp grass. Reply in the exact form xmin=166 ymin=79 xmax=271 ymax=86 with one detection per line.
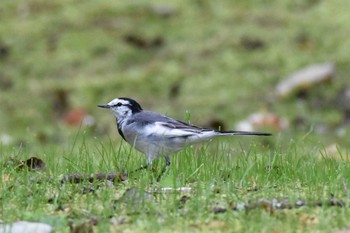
xmin=0 ymin=0 xmax=350 ymax=149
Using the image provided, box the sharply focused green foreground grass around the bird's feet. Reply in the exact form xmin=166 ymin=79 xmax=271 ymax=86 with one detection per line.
xmin=0 ymin=135 xmax=350 ymax=232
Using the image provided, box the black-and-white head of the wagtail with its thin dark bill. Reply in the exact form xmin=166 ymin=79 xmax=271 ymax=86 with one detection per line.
xmin=97 ymin=97 xmax=142 ymax=120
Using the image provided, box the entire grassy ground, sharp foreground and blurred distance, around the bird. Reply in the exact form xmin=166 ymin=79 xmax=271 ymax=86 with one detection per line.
xmin=0 ymin=0 xmax=350 ymax=232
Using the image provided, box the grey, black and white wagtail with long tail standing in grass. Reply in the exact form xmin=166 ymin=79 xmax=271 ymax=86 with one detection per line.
xmin=98 ymin=98 xmax=271 ymax=167
